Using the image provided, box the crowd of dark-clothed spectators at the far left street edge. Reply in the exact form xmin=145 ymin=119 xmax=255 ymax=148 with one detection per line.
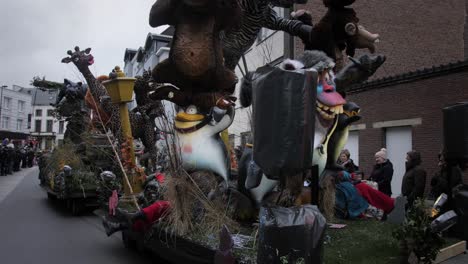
xmin=0 ymin=138 xmax=35 ymax=176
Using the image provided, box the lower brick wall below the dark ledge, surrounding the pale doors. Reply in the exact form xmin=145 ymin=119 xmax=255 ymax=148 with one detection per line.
xmin=347 ymin=67 xmax=468 ymax=193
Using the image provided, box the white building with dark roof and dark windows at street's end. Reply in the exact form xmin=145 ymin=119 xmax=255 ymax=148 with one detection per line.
xmin=30 ymin=89 xmax=67 ymax=150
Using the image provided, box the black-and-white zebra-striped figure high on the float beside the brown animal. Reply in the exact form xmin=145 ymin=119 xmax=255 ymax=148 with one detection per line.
xmin=221 ymin=0 xmax=312 ymax=70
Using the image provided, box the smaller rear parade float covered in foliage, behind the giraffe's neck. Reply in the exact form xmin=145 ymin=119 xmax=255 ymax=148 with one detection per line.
xmin=32 ymin=78 xmax=114 ymax=215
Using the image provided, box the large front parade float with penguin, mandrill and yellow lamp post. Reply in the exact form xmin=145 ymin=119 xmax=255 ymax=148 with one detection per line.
xmin=54 ymin=0 xmax=394 ymax=263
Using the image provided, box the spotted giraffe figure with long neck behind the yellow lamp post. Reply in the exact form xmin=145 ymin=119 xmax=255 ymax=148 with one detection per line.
xmin=62 ymin=46 xmax=161 ymax=169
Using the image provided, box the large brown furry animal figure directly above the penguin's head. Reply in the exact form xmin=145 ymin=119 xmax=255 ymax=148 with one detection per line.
xmin=149 ymin=0 xmax=240 ymax=109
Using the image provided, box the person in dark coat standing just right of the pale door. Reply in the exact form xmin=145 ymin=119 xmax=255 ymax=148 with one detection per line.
xmin=401 ymin=150 xmax=427 ymax=209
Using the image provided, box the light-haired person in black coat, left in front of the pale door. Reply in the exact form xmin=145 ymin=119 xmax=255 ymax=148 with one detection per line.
xmin=369 ymin=148 xmax=393 ymax=196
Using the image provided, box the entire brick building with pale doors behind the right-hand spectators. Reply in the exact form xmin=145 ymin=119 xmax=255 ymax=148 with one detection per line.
xmin=294 ymin=0 xmax=468 ymax=195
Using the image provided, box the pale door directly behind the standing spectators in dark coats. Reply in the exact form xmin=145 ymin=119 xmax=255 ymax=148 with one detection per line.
xmin=385 ymin=126 xmax=413 ymax=197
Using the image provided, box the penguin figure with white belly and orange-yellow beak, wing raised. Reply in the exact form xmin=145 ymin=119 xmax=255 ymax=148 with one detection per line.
xmin=174 ymin=105 xmax=235 ymax=181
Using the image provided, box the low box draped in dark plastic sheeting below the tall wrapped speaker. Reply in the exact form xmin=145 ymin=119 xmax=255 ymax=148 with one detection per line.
xmin=257 ymin=205 xmax=326 ymax=264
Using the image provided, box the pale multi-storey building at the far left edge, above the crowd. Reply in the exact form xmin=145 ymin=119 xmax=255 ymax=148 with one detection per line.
xmin=0 ymin=85 xmax=33 ymax=144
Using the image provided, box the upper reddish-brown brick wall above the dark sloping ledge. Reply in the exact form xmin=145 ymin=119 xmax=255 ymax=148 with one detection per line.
xmin=295 ymin=0 xmax=466 ymax=78
